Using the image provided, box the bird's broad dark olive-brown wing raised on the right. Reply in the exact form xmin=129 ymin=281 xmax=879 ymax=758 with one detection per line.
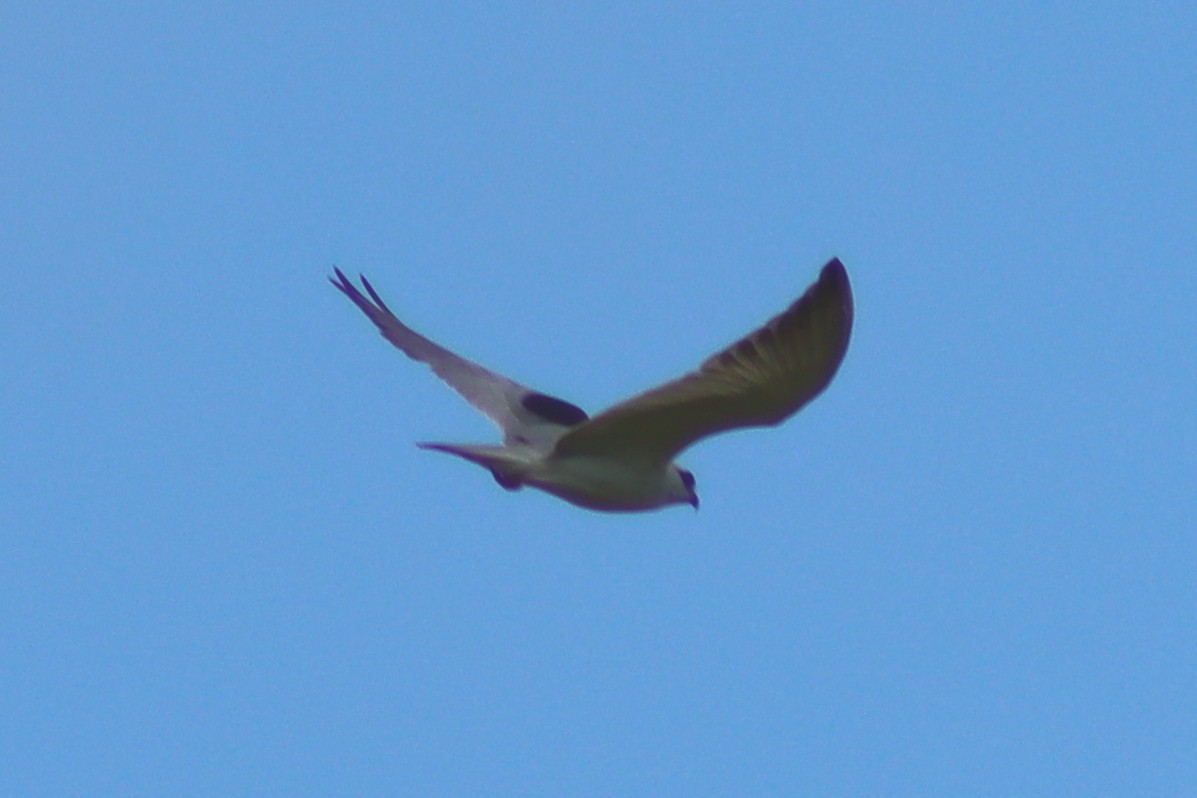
xmin=553 ymin=258 xmax=852 ymax=463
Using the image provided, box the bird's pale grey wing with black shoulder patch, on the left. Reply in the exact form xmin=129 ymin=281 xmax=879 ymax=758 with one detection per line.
xmin=329 ymin=269 xmax=587 ymax=447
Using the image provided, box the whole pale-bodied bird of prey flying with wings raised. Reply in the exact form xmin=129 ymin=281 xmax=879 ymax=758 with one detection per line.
xmin=329 ymin=258 xmax=852 ymax=512
